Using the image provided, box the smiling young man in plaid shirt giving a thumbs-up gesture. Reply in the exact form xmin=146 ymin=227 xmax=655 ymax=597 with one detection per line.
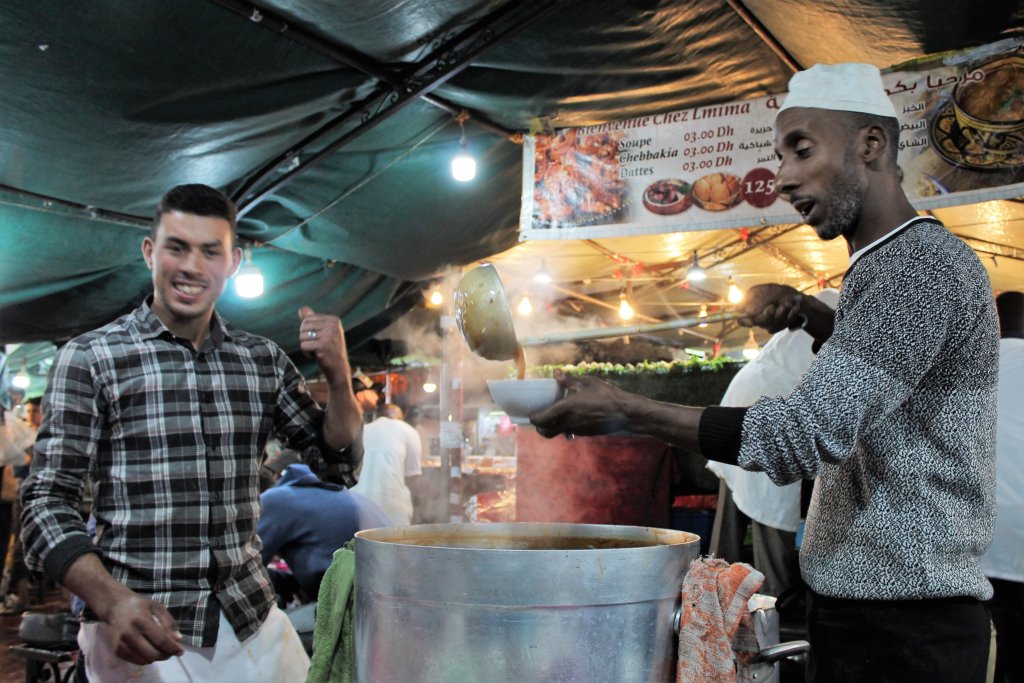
xmin=23 ymin=185 xmax=362 ymax=682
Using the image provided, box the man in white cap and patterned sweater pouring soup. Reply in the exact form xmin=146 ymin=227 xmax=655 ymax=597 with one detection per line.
xmin=530 ymin=63 xmax=998 ymax=683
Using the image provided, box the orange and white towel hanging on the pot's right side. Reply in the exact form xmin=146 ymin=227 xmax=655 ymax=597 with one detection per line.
xmin=676 ymin=557 xmax=765 ymax=683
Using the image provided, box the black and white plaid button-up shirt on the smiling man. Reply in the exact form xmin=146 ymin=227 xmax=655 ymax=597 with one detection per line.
xmin=23 ymin=301 xmax=361 ymax=647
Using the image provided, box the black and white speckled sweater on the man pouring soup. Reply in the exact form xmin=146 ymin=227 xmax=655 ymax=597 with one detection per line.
xmin=701 ymin=220 xmax=998 ymax=600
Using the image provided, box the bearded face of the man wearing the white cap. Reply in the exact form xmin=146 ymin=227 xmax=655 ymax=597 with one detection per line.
xmin=775 ymin=108 xmax=868 ymax=240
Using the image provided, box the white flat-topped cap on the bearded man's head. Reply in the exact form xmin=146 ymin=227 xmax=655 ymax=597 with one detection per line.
xmin=779 ymin=62 xmax=897 ymax=119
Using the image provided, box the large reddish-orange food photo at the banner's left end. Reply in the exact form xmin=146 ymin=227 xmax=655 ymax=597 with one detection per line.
xmin=534 ymin=129 xmax=626 ymax=226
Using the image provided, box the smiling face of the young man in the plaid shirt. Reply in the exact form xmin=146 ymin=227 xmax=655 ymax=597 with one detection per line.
xmin=142 ymin=211 xmax=242 ymax=346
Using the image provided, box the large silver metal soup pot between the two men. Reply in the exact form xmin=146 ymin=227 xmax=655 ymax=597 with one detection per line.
xmin=355 ymin=522 xmax=699 ymax=683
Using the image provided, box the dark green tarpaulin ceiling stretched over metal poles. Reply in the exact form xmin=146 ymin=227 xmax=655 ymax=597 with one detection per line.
xmin=0 ymin=0 xmax=1024 ymax=382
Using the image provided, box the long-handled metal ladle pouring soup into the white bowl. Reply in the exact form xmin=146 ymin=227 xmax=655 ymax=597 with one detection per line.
xmin=455 ymin=264 xmax=739 ymax=360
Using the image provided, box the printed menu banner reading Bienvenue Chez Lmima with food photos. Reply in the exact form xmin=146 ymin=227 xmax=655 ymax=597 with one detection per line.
xmin=520 ymin=38 xmax=1024 ymax=240
